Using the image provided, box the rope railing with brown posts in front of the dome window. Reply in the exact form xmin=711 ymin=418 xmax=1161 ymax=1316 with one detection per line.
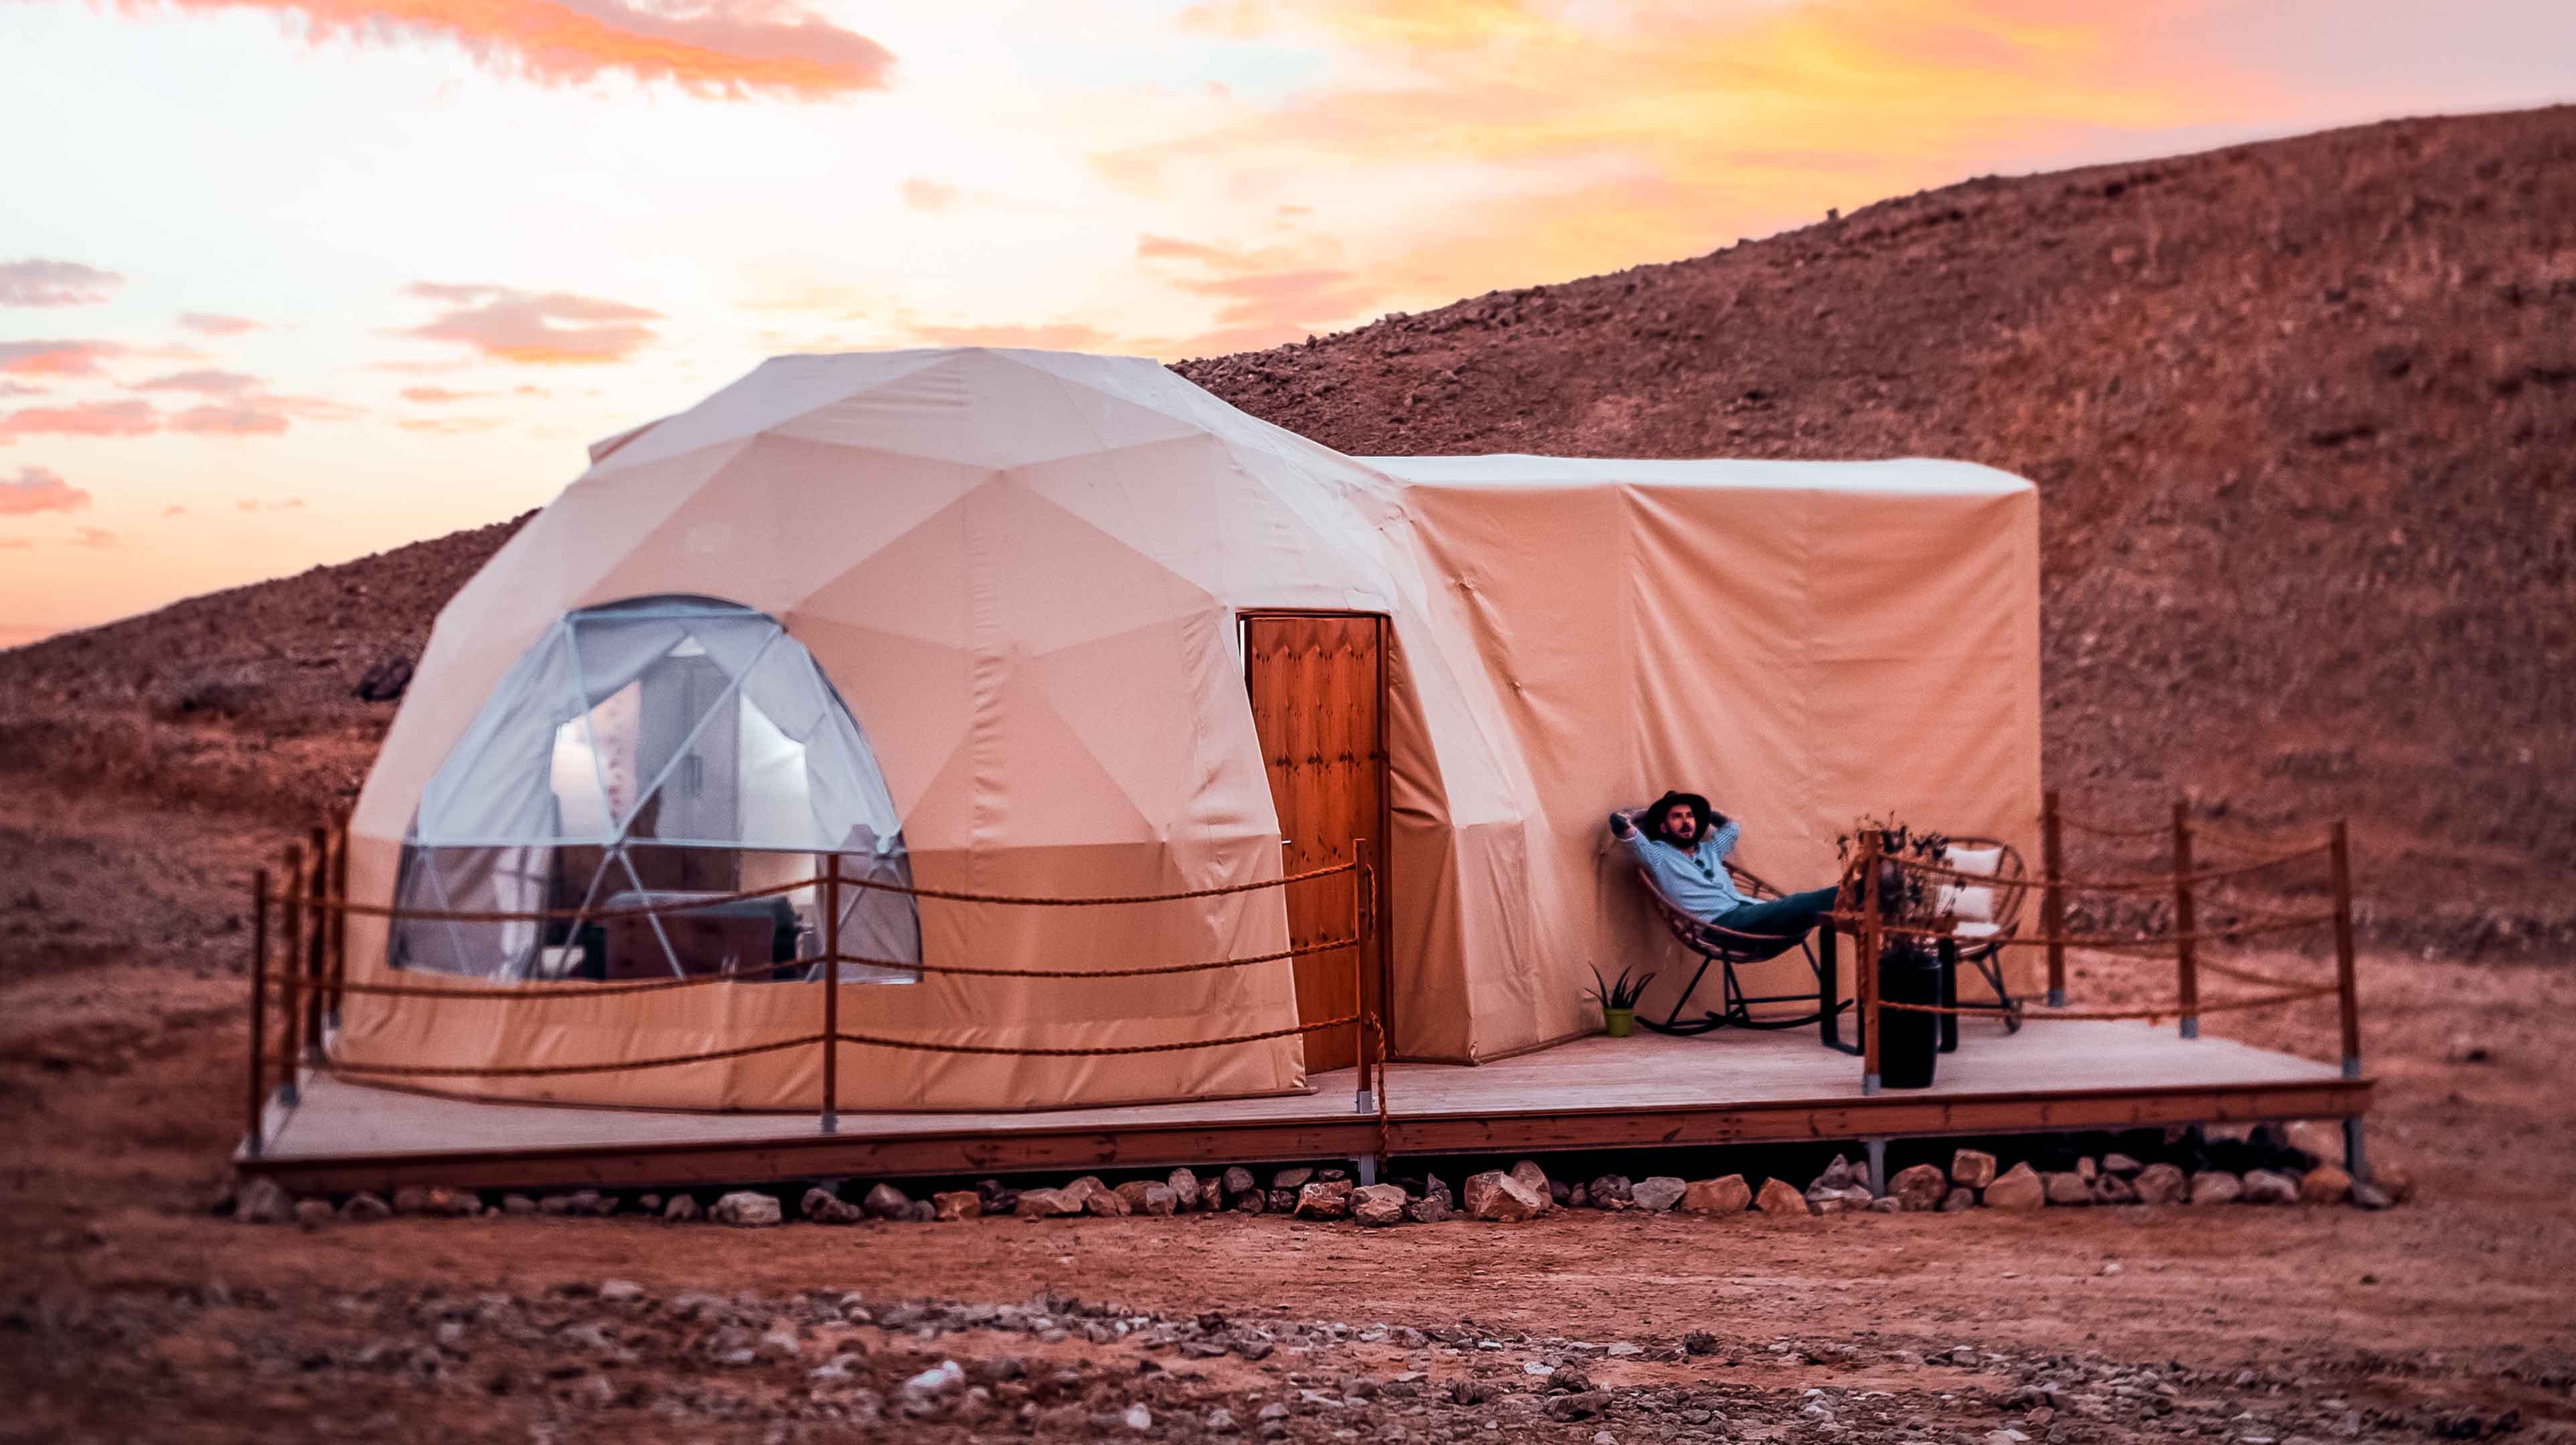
xmin=245 ymin=819 xmax=1388 ymax=1154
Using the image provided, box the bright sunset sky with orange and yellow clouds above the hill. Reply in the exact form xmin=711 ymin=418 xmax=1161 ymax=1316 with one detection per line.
xmin=0 ymin=0 xmax=2576 ymax=646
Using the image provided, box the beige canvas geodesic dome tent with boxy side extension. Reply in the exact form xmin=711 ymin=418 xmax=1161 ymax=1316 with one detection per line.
xmin=333 ymin=351 xmax=2040 ymax=1110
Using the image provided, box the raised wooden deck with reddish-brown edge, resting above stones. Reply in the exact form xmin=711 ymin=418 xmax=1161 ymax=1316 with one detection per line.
xmin=234 ymin=1020 xmax=2370 ymax=1193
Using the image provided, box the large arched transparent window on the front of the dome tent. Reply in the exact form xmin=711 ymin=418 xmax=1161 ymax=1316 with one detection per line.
xmin=391 ymin=597 xmax=922 ymax=984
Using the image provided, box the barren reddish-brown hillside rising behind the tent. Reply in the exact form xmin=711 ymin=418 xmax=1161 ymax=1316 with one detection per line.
xmin=0 ymin=108 xmax=2576 ymax=948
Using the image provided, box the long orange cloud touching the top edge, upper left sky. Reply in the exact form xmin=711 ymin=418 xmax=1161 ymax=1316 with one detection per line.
xmin=148 ymin=0 xmax=894 ymax=100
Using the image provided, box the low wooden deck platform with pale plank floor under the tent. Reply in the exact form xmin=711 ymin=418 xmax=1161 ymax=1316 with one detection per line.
xmin=245 ymin=1020 xmax=2367 ymax=1179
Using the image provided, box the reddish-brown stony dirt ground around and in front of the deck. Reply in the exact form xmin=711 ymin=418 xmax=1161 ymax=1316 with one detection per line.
xmin=0 ymin=791 xmax=2576 ymax=1445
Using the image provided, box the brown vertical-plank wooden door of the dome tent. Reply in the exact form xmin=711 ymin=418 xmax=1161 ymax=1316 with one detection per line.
xmin=1242 ymin=613 xmax=1394 ymax=1072
